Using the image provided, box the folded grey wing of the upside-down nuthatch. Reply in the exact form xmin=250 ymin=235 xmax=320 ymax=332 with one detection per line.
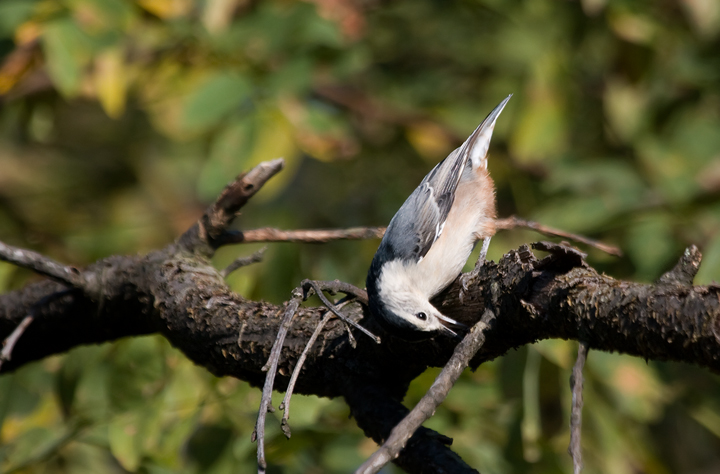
xmin=383 ymin=147 xmax=467 ymax=262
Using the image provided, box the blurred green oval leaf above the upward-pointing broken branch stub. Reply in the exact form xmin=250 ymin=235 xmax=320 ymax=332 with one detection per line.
xmin=182 ymin=72 xmax=252 ymax=131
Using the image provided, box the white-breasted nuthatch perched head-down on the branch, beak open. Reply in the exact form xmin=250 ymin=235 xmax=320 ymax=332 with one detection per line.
xmin=366 ymin=94 xmax=512 ymax=340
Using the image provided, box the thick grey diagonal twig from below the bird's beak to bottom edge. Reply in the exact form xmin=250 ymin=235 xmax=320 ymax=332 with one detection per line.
xmin=355 ymin=309 xmax=495 ymax=474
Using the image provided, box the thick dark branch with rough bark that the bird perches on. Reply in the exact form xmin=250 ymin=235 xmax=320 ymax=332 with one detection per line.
xmin=0 ymin=164 xmax=720 ymax=473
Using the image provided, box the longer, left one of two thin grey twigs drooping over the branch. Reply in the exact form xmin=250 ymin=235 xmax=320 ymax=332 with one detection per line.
xmin=251 ymin=288 xmax=303 ymax=474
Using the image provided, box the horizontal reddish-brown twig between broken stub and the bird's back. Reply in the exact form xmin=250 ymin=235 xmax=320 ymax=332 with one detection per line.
xmin=222 ymin=227 xmax=386 ymax=245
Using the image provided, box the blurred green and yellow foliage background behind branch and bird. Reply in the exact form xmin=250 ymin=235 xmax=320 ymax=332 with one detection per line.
xmin=0 ymin=0 xmax=720 ymax=474
